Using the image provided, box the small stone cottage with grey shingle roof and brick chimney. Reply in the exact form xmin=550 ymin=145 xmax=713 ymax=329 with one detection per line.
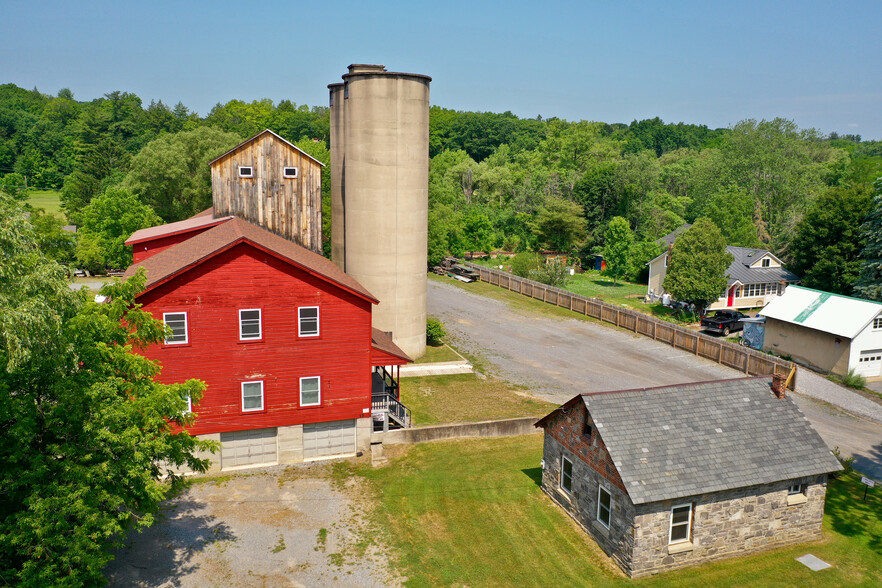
xmin=536 ymin=376 xmax=841 ymax=577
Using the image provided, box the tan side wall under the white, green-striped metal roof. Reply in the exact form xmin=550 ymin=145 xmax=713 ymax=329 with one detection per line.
xmin=763 ymin=317 xmax=851 ymax=375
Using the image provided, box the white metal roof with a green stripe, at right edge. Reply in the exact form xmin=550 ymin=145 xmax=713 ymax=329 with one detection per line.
xmin=760 ymin=286 xmax=882 ymax=339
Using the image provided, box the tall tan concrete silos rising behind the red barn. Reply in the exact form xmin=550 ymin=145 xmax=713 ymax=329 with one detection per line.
xmin=329 ymin=65 xmax=432 ymax=358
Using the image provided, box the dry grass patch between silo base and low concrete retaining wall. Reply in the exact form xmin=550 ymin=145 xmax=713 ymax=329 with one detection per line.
xmin=400 ymin=374 xmax=557 ymax=426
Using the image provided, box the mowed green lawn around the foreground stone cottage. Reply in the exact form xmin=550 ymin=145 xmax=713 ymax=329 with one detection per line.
xmin=350 ymin=435 xmax=882 ymax=587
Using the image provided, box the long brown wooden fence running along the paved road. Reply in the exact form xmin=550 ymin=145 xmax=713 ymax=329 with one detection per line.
xmin=460 ymin=261 xmax=796 ymax=390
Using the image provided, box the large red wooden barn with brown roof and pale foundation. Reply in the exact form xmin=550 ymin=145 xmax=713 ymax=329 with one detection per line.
xmin=126 ymin=211 xmax=410 ymax=469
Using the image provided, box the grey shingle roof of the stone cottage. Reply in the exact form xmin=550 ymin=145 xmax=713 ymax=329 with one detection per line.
xmin=582 ymin=378 xmax=841 ymax=504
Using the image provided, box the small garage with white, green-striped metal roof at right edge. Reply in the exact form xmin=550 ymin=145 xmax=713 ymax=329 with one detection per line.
xmin=760 ymin=286 xmax=882 ymax=379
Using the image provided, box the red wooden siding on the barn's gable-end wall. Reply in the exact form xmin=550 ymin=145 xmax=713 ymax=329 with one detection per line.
xmin=138 ymin=243 xmax=372 ymax=434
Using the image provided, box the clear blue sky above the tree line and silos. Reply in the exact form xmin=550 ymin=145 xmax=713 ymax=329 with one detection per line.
xmin=0 ymin=0 xmax=882 ymax=139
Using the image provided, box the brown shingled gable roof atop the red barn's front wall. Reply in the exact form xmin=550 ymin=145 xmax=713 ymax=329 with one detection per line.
xmin=125 ymin=217 xmax=379 ymax=304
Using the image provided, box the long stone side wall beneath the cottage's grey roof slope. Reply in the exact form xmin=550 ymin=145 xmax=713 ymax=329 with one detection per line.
xmin=626 ymin=474 xmax=827 ymax=577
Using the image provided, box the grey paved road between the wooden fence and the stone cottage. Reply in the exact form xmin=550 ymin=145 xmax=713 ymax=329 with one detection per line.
xmin=428 ymin=280 xmax=882 ymax=480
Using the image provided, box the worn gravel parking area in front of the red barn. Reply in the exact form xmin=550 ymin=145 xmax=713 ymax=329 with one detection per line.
xmin=105 ymin=464 xmax=401 ymax=587
